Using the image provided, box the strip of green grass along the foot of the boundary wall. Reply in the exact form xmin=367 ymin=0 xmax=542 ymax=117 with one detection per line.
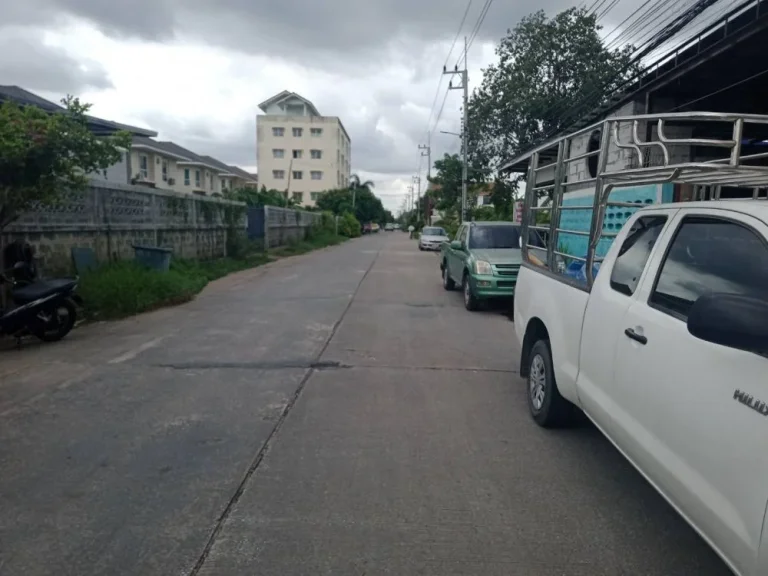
xmin=77 ymin=233 xmax=346 ymax=320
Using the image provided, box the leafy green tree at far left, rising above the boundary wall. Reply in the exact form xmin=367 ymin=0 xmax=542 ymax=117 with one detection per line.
xmin=0 ymin=96 xmax=131 ymax=230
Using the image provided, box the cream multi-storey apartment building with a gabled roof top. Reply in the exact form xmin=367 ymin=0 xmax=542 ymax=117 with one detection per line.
xmin=256 ymin=90 xmax=352 ymax=206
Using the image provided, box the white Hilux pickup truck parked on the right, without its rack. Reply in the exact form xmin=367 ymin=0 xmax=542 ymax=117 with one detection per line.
xmin=514 ymin=200 xmax=768 ymax=576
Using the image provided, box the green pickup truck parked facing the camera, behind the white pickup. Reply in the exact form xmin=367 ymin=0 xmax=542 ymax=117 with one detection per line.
xmin=440 ymin=222 xmax=522 ymax=310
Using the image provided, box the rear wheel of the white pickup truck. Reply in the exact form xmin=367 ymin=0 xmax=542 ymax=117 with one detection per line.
xmin=528 ymin=340 xmax=574 ymax=428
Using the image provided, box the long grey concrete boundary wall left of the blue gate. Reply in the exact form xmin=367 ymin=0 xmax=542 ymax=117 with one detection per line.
xmin=0 ymin=180 xmax=247 ymax=274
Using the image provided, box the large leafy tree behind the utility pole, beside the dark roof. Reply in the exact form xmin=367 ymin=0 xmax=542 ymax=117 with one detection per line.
xmin=467 ymin=8 xmax=638 ymax=171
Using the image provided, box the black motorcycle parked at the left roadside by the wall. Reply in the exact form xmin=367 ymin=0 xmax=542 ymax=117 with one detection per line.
xmin=0 ymin=244 xmax=83 ymax=347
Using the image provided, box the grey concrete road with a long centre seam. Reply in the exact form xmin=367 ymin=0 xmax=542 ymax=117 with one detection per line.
xmin=0 ymin=232 xmax=728 ymax=576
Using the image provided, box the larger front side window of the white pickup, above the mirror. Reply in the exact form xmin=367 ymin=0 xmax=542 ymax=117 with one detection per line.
xmin=648 ymin=217 xmax=768 ymax=319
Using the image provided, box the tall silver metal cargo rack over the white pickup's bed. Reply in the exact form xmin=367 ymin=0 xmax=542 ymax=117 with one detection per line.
xmin=510 ymin=112 xmax=768 ymax=289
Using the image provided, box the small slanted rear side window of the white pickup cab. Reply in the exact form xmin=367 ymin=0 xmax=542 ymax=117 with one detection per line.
xmin=611 ymin=216 xmax=667 ymax=296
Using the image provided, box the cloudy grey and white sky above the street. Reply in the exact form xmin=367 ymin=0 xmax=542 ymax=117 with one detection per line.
xmin=0 ymin=0 xmax=712 ymax=211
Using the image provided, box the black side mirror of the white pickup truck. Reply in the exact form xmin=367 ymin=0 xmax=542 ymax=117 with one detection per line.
xmin=688 ymin=293 xmax=768 ymax=355
